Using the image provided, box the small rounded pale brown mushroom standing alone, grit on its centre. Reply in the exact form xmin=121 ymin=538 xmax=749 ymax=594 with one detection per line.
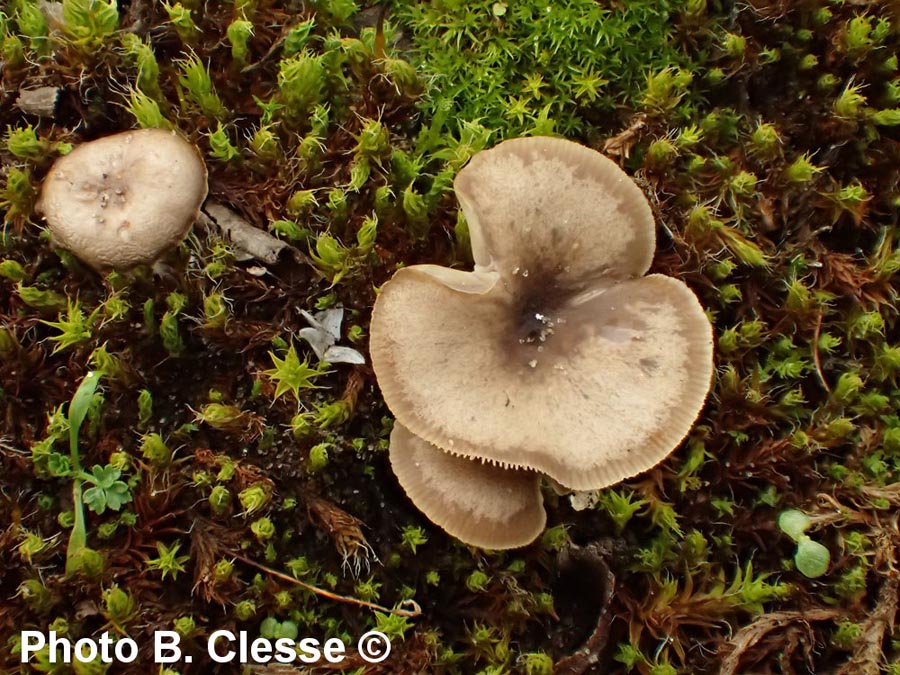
xmin=38 ymin=129 xmax=207 ymax=271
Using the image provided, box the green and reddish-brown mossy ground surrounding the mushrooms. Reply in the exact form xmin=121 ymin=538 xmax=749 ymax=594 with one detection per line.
xmin=0 ymin=0 xmax=900 ymax=675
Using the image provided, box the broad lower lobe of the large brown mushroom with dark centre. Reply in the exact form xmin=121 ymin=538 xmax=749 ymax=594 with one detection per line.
xmin=369 ymin=254 xmax=713 ymax=490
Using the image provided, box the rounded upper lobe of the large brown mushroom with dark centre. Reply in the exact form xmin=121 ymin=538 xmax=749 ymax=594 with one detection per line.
xmin=453 ymin=136 xmax=656 ymax=286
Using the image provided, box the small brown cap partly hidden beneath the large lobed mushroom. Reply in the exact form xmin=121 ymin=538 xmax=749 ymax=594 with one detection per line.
xmin=390 ymin=423 xmax=547 ymax=549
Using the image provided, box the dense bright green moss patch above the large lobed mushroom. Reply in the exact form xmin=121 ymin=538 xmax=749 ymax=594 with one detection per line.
xmin=395 ymin=0 xmax=683 ymax=140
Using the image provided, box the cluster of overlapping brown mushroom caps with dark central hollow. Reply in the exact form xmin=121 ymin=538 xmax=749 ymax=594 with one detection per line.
xmin=370 ymin=137 xmax=713 ymax=548
